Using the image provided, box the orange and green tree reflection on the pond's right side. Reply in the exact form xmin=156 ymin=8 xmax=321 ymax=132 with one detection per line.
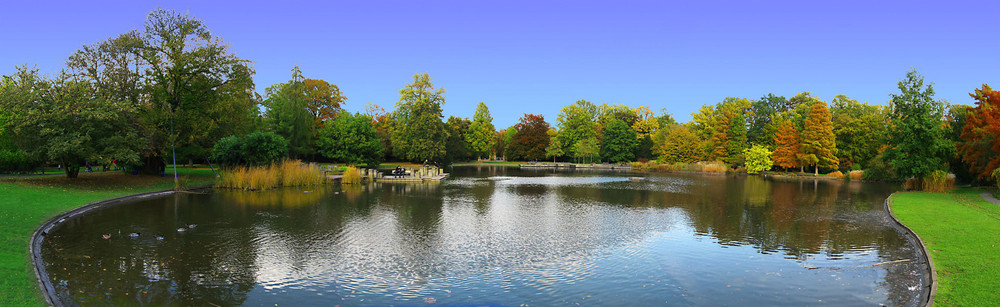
xmin=552 ymin=175 xmax=905 ymax=259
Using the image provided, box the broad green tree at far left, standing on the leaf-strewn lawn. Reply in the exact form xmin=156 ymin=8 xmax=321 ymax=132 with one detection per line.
xmin=0 ymin=67 xmax=142 ymax=178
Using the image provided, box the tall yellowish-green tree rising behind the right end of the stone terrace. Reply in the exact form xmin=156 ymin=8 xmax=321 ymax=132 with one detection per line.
xmin=391 ymin=73 xmax=448 ymax=162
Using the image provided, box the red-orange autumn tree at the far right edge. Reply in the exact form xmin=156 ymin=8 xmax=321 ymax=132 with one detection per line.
xmin=958 ymin=84 xmax=1000 ymax=180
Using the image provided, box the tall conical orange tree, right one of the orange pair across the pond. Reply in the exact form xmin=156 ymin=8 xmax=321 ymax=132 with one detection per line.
xmin=802 ymin=101 xmax=840 ymax=175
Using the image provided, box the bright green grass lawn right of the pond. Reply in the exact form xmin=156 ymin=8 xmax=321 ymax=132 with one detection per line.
xmin=892 ymin=188 xmax=1000 ymax=306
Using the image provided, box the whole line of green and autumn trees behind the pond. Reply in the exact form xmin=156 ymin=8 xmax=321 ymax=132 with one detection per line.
xmin=0 ymin=10 xmax=1000 ymax=189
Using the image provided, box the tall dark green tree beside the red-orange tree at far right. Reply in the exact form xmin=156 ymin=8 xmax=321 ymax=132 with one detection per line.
xmin=885 ymin=70 xmax=954 ymax=186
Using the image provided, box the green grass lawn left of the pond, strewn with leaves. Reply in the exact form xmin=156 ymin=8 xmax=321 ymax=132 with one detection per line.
xmin=0 ymin=168 xmax=215 ymax=306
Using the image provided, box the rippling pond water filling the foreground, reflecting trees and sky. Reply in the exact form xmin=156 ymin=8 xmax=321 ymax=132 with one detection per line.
xmin=42 ymin=167 xmax=926 ymax=306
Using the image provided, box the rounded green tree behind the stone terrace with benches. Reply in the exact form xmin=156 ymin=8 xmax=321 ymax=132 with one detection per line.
xmin=316 ymin=111 xmax=383 ymax=168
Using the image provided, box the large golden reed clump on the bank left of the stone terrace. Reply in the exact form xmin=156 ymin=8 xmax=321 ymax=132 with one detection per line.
xmin=216 ymin=160 xmax=325 ymax=191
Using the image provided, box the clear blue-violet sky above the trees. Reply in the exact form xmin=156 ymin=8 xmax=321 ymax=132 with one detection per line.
xmin=0 ymin=1 xmax=1000 ymax=128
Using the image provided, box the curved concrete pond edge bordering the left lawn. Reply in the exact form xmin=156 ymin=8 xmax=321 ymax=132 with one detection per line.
xmin=28 ymin=186 xmax=212 ymax=307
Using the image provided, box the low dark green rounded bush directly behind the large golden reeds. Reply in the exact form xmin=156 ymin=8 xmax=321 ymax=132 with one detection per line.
xmin=212 ymin=131 xmax=288 ymax=166
